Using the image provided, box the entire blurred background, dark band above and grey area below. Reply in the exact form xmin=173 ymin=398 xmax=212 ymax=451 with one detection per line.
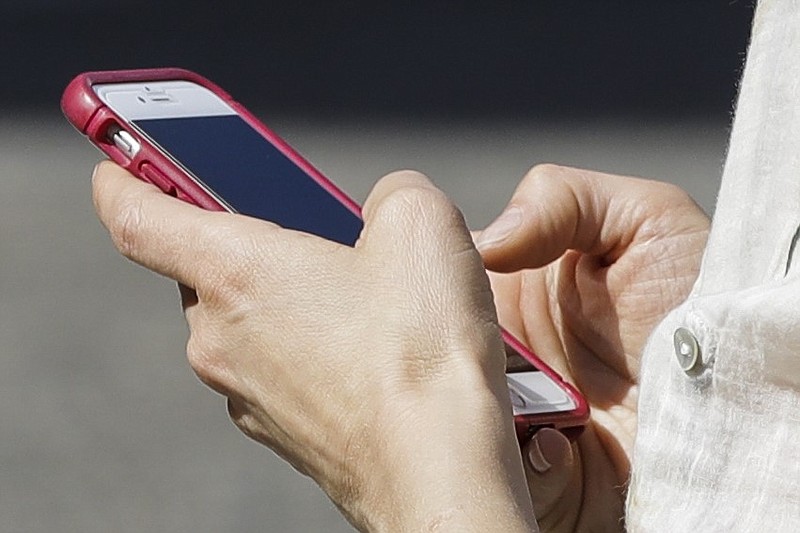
xmin=0 ymin=0 xmax=752 ymax=532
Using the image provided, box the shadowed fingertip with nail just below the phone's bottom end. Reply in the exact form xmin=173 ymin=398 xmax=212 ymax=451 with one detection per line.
xmin=523 ymin=428 xmax=581 ymax=531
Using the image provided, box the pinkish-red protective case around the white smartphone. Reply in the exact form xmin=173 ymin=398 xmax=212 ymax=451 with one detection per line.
xmin=61 ymin=68 xmax=589 ymax=442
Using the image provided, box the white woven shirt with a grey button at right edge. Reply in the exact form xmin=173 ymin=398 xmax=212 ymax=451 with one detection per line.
xmin=626 ymin=0 xmax=800 ymax=533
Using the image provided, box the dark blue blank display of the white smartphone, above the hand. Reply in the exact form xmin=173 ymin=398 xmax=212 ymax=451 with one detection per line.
xmin=135 ymin=115 xmax=362 ymax=246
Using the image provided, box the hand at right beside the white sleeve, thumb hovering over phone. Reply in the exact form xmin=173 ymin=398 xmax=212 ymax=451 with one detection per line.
xmin=475 ymin=165 xmax=709 ymax=532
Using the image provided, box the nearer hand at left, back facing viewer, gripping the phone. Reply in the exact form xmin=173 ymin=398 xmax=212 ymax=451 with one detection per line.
xmin=93 ymin=163 xmax=536 ymax=531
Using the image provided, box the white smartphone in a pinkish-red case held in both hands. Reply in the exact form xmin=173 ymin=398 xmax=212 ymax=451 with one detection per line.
xmin=61 ymin=69 xmax=589 ymax=442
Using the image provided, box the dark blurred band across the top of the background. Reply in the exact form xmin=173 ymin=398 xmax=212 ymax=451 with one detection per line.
xmin=0 ymin=0 xmax=753 ymax=118
